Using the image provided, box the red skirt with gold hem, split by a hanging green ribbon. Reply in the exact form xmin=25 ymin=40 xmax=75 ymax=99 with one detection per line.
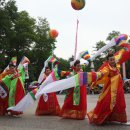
xmin=60 ymin=86 xmax=87 ymax=120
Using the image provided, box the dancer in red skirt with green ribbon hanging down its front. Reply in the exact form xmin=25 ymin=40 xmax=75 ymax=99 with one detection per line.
xmin=60 ymin=60 xmax=87 ymax=120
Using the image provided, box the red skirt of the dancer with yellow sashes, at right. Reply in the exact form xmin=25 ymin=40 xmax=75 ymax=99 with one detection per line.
xmin=87 ymin=78 xmax=127 ymax=125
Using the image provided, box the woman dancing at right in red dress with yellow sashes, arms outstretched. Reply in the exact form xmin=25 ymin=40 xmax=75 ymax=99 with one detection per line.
xmin=87 ymin=51 xmax=130 ymax=125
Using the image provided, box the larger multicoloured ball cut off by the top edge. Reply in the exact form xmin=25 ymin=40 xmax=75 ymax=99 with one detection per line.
xmin=71 ymin=0 xmax=85 ymax=10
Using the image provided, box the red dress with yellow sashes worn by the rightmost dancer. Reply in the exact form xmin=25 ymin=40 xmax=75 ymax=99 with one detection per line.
xmin=87 ymin=64 xmax=127 ymax=124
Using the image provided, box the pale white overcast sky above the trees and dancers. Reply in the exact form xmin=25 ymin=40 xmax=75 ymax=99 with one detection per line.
xmin=16 ymin=0 xmax=130 ymax=59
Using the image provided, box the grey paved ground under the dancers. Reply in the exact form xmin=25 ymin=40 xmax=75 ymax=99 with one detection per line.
xmin=0 ymin=94 xmax=130 ymax=130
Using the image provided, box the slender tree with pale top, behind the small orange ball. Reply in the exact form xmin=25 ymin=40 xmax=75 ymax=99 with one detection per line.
xmin=31 ymin=18 xmax=55 ymax=77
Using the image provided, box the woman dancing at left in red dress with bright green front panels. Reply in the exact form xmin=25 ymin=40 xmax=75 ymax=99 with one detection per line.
xmin=0 ymin=56 xmax=29 ymax=115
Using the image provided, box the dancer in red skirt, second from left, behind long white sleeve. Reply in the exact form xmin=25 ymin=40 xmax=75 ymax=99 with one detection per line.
xmin=35 ymin=67 xmax=60 ymax=116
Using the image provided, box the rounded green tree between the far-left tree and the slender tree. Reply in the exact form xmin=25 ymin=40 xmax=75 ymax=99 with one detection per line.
xmin=11 ymin=11 xmax=35 ymax=55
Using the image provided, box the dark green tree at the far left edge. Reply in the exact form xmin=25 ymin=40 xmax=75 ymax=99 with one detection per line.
xmin=0 ymin=1 xmax=17 ymax=64
